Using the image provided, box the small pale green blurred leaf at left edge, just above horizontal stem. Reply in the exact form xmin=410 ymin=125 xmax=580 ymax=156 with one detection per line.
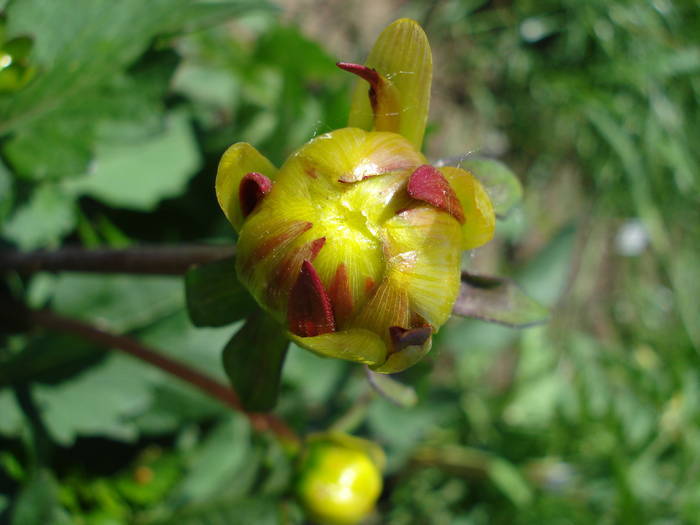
xmin=2 ymin=184 xmax=77 ymax=250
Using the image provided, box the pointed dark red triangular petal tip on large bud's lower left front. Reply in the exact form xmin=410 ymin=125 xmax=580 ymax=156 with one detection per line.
xmin=287 ymin=260 xmax=335 ymax=337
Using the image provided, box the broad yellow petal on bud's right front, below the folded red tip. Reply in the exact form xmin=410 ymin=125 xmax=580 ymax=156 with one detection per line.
xmin=384 ymin=206 xmax=461 ymax=329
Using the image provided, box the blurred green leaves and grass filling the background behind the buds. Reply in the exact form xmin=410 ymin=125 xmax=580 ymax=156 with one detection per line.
xmin=0 ymin=0 xmax=700 ymax=525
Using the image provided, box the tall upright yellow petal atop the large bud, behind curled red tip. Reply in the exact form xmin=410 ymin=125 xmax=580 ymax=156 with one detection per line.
xmin=348 ymin=18 xmax=433 ymax=150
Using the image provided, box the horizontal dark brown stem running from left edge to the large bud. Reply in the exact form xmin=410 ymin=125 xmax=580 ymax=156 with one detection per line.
xmin=0 ymin=245 xmax=235 ymax=275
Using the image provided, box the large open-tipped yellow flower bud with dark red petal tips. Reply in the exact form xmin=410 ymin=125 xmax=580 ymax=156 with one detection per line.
xmin=216 ymin=19 xmax=495 ymax=373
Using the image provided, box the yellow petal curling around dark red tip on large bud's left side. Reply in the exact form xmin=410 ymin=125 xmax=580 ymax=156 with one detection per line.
xmin=216 ymin=142 xmax=277 ymax=231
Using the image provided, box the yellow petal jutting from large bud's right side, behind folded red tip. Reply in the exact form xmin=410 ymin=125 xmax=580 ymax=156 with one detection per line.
xmin=440 ymin=166 xmax=496 ymax=250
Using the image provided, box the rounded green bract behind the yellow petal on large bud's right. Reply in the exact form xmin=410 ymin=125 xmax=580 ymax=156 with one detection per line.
xmin=460 ymin=158 xmax=523 ymax=218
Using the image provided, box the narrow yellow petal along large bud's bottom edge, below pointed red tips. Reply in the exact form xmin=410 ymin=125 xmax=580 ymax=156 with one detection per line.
xmin=287 ymin=328 xmax=387 ymax=366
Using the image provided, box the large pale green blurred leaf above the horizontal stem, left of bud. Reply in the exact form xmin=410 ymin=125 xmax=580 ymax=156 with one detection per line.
xmin=65 ymin=111 xmax=200 ymax=211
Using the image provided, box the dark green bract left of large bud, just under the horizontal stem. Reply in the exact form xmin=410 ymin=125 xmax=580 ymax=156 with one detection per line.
xmin=185 ymin=257 xmax=256 ymax=326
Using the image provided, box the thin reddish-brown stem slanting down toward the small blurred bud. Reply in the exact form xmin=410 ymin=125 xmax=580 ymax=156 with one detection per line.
xmin=27 ymin=310 xmax=299 ymax=443
